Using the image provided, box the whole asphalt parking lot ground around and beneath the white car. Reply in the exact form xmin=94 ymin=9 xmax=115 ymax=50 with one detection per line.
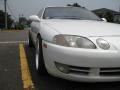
xmin=0 ymin=31 xmax=120 ymax=90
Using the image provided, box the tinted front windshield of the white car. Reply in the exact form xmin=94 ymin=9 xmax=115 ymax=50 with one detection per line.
xmin=43 ymin=7 xmax=101 ymax=20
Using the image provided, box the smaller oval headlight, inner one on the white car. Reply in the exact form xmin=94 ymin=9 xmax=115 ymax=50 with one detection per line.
xmin=96 ymin=38 xmax=110 ymax=50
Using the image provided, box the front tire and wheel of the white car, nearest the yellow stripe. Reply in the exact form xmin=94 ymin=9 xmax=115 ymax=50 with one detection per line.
xmin=35 ymin=36 xmax=47 ymax=74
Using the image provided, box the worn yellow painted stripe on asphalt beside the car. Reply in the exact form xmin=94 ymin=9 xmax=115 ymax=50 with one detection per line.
xmin=19 ymin=44 xmax=35 ymax=90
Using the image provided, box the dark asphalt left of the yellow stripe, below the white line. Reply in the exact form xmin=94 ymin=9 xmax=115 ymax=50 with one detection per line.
xmin=0 ymin=44 xmax=23 ymax=90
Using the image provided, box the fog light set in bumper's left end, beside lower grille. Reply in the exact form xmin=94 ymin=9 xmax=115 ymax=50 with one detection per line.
xmin=55 ymin=62 xmax=69 ymax=74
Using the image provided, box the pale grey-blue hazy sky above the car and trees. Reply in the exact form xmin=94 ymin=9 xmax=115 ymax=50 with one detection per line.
xmin=0 ymin=0 xmax=120 ymax=19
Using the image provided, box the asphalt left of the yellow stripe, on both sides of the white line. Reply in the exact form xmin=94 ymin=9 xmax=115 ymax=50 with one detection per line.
xmin=0 ymin=31 xmax=28 ymax=90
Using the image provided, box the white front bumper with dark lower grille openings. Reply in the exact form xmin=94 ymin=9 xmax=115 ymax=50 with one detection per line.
xmin=43 ymin=41 xmax=120 ymax=82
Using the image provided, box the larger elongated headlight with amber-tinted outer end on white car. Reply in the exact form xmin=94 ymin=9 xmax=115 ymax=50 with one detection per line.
xmin=53 ymin=35 xmax=96 ymax=49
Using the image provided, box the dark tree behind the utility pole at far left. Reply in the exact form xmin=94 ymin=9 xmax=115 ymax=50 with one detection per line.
xmin=0 ymin=10 xmax=13 ymax=29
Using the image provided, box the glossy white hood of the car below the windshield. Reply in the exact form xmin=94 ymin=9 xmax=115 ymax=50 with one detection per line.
xmin=44 ymin=19 xmax=120 ymax=36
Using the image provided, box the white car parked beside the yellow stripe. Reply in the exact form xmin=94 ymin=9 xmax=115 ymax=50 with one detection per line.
xmin=29 ymin=7 xmax=120 ymax=82
